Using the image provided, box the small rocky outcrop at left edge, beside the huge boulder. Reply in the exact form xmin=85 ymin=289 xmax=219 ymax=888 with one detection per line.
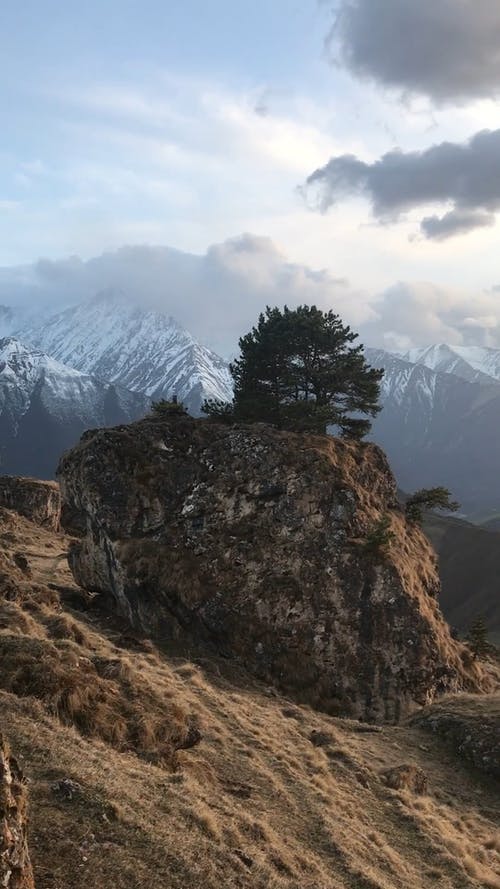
xmin=0 ymin=475 xmax=61 ymax=531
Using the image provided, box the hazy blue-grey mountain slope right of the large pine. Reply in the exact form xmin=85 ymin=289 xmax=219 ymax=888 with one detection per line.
xmin=366 ymin=349 xmax=500 ymax=515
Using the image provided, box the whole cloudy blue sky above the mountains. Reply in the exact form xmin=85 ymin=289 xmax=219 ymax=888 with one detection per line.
xmin=0 ymin=0 xmax=500 ymax=353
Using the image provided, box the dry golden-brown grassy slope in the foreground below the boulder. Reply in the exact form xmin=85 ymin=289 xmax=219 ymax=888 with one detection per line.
xmin=0 ymin=492 xmax=500 ymax=889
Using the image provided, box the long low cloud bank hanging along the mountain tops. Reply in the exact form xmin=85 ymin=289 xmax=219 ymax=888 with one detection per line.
xmin=0 ymin=234 xmax=500 ymax=356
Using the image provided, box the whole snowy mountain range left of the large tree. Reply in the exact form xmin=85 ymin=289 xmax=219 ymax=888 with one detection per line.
xmin=0 ymin=291 xmax=232 ymax=478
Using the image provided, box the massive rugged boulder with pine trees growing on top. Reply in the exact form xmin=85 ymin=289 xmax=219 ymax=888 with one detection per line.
xmin=59 ymin=417 xmax=480 ymax=721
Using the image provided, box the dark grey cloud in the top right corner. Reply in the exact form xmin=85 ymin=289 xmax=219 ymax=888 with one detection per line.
xmin=329 ymin=0 xmax=500 ymax=104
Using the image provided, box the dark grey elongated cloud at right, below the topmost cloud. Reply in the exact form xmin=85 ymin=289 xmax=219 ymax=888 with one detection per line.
xmin=305 ymin=130 xmax=500 ymax=239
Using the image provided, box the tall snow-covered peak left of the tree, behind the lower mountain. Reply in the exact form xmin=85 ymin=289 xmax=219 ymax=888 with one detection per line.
xmin=20 ymin=290 xmax=232 ymax=414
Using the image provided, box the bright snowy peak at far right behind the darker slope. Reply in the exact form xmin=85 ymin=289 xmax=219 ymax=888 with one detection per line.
xmin=401 ymin=343 xmax=500 ymax=383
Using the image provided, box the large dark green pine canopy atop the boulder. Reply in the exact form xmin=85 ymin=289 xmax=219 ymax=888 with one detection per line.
xmin=204 ymin=306 xmax=383 ymax=438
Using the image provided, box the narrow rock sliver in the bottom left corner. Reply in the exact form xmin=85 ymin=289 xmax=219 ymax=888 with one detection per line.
xmin=0 ymin=735 xmax=35 ymax=889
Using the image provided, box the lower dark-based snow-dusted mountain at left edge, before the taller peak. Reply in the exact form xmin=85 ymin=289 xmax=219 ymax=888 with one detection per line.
xmin=0 ymin=337 xmax=149 ymax=478
